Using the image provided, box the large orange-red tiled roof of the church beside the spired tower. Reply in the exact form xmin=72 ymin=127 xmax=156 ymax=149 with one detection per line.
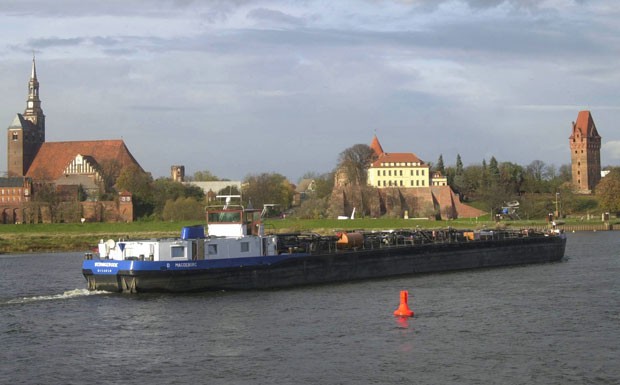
xmin=26 ymin=140 xmax=142 ymax=181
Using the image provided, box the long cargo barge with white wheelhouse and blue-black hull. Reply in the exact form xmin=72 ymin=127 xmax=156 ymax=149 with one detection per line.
xmin=82 ymin=206 xmax=566 ymax=293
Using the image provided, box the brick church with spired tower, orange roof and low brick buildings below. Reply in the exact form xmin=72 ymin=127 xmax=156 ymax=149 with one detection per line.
xmin=0 ymin=57 xmax=144 ymax=224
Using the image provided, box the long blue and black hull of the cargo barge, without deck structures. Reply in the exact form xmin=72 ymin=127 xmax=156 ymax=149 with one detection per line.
xmin=82 ymin=232 xmax=566 ymax=293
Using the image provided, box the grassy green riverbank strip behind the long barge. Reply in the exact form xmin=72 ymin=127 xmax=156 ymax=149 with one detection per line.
xmin=0 ymin=218 xmax=620 ymax=254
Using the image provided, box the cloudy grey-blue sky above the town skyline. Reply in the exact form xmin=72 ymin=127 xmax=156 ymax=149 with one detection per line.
xmin=0 ymin=0 xmax=620 ymax=183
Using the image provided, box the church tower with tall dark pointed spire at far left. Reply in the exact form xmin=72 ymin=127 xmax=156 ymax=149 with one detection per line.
xmin=7 ymin=57 xmax=45 ymax=177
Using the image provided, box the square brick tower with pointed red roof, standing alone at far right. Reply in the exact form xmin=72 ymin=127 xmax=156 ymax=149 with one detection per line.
xmin=569 ymin=111 xmax=601 ymax=194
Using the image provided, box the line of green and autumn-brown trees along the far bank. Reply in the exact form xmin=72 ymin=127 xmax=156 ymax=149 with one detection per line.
xmin=29 ymin=144 xmax=620 ymax=220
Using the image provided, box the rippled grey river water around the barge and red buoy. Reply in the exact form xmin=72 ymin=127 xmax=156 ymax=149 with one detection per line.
xmin=0 ymin=232 xmax=620 ymax=385
